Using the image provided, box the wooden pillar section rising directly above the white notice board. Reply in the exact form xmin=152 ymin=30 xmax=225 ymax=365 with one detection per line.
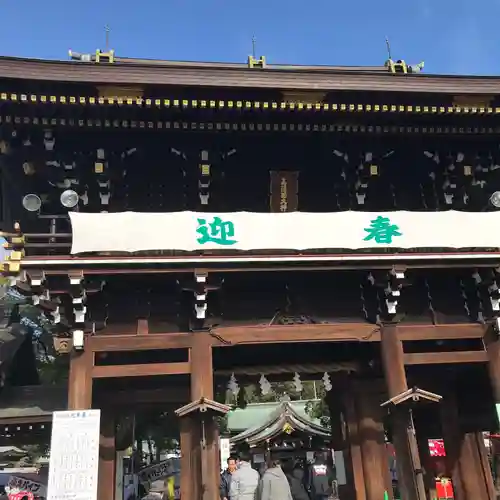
xmin=68 ymin=350 xmax=94 ymax=410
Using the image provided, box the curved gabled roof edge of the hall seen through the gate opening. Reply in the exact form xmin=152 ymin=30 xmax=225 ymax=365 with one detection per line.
xmin=231 ymin=401 xmax=330 ymax=445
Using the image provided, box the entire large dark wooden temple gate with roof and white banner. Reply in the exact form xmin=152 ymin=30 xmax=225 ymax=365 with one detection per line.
xmin=0 ymin=53 xmax=500 ymax=500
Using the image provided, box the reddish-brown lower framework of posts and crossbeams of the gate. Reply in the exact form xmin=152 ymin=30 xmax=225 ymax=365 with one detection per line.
xmin=56 ymin=320 xmax=500 ymax=500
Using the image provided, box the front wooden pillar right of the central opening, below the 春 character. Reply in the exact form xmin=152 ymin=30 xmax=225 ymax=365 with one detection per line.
xmin=381 ymin=325 xmax=425 ymax=500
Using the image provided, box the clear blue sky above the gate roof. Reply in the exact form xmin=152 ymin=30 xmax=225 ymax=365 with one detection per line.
xmin=0 ymin=0 xmax=500 ymax=74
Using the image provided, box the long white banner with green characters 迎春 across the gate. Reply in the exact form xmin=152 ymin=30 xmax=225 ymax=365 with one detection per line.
xmin=70 ymin=211 xmax=500 ymax=254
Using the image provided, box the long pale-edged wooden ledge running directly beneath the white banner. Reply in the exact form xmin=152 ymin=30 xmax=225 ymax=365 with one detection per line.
xmin=21 ymin=252 xmax=500 ymax=276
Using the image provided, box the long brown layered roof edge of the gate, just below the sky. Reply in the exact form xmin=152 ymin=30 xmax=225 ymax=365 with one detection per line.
xmin=0 ymin=57 xmax=500 ymax=95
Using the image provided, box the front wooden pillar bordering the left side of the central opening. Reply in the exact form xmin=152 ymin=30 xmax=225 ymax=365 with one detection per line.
xmin=181 ymin=332 xmax=220 ymax=500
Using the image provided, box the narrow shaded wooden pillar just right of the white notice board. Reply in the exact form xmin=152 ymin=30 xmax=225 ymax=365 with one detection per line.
xmin=97 ymin=409 xmax=116 ymax=500
